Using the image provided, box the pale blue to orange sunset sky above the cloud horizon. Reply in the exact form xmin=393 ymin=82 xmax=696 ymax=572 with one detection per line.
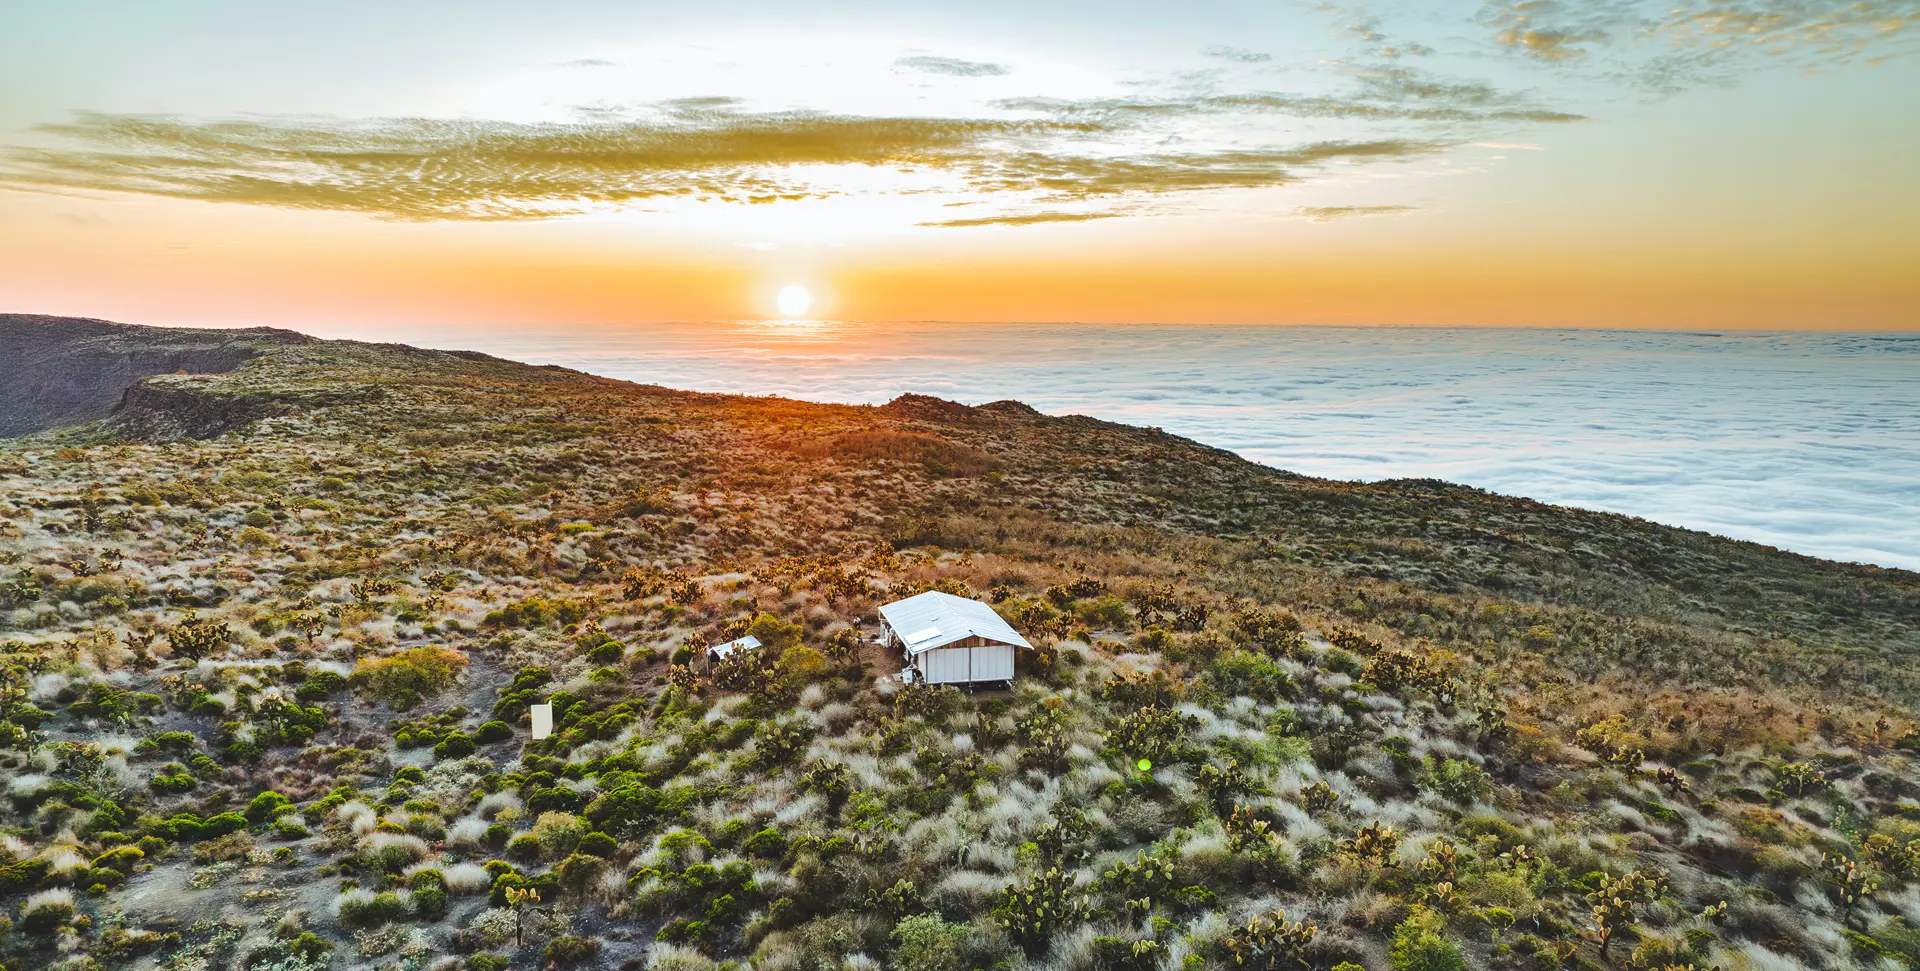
xmin=0 ymin=0 xmax=1920 ymax=336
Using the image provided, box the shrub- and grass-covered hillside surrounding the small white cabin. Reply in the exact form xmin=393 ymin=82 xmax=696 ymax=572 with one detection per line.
xmin=0 ymin=317 xmax=1920 ymax=971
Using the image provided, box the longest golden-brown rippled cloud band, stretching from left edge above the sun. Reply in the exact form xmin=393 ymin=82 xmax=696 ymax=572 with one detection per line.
xmin=0 ymin=71 xmax=1466 ymax=226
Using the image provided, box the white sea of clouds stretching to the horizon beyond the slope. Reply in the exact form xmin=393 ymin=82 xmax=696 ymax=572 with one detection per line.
xmin=399 ymin=322 xmax=1920 ymax=570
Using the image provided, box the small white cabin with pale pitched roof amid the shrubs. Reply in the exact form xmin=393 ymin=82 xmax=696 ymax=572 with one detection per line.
xmin=879 ymin=591 xmax=1033 ymax=685
